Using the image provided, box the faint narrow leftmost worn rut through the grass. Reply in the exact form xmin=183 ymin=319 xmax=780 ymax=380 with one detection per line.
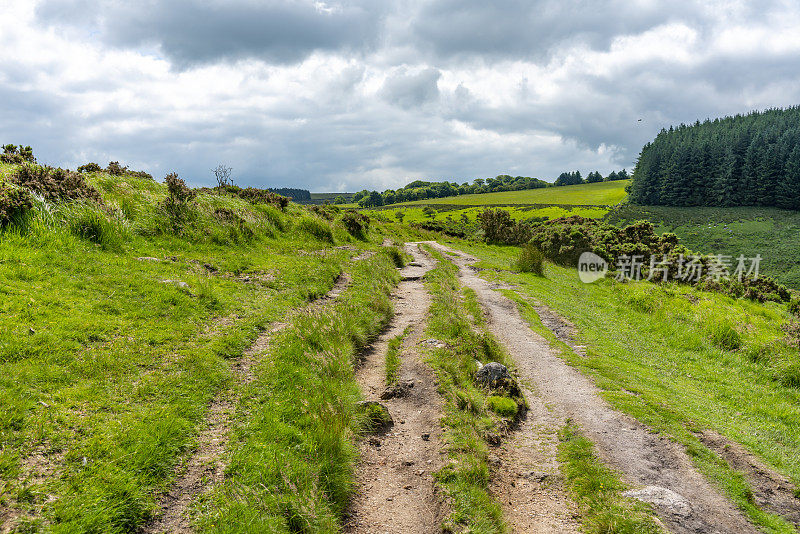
xmin=145 ymin=253 xmax=364 ymax=534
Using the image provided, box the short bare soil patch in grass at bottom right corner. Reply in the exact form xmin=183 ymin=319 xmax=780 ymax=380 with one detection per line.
xmin=697 ymin=430 xmax=800 ymax=526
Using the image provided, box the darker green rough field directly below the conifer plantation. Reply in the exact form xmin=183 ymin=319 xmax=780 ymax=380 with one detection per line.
xmin=608 ymin=205 xmax=800 ymax=289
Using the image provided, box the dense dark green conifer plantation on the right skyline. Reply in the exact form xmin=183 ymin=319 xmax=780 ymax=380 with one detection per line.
xmin=630 ymin=106 xmax=800 ymax=210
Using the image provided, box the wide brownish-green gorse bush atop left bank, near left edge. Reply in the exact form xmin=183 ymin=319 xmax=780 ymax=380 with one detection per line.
xmin=9 ymin=164 xmax=103 ymax=204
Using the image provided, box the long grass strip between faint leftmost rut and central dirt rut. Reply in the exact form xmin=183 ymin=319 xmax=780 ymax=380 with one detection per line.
xmin=198 ymin=254 xmax=398 ymax=533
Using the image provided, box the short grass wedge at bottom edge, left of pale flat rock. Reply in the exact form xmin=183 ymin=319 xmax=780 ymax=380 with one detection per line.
xmin=558 ymin=421 xmax=663 ymax=534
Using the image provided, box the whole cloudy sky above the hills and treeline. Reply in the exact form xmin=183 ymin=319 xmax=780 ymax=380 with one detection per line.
xmin=0 ymin=0 xmax=800 ymax=191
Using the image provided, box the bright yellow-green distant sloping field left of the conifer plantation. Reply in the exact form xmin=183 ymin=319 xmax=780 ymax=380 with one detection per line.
xmin=397 ymin=180 xmax=630 ymax=210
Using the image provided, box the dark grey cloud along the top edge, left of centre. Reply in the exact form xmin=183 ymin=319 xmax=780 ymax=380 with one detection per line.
xmin=37 ymin=0 xmax=385 ymax=68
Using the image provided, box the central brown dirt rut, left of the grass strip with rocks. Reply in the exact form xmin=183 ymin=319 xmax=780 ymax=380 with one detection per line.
xmin=345 ymin=245 xmax=445 ymax=534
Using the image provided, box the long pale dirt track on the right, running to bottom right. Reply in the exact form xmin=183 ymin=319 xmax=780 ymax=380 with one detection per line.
xmin=431 ymin=243 xmax=756 ymax=533
